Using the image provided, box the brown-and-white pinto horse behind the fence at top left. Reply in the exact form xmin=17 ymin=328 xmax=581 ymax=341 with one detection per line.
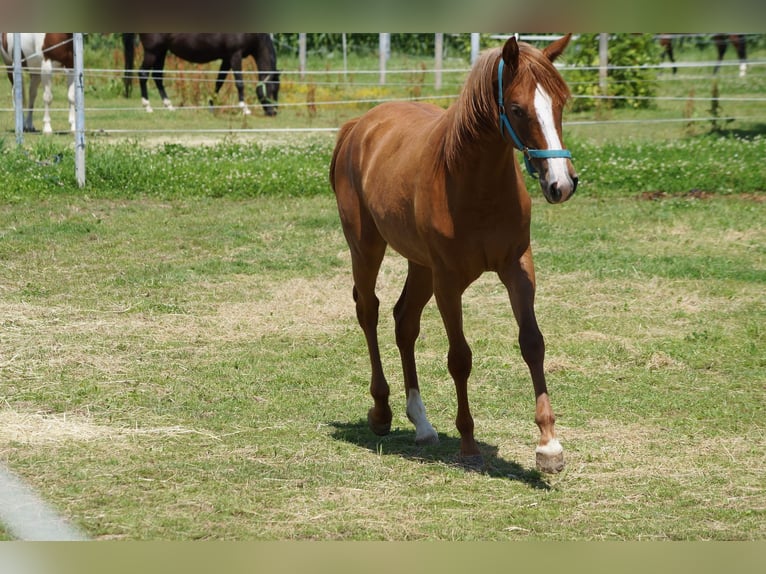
xmin=0 ymin=32 xmax=75 ymax=134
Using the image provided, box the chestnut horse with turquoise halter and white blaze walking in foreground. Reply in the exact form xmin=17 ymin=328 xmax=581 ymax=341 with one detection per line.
xmin=330 ymin=35 xmax=577 ymax=472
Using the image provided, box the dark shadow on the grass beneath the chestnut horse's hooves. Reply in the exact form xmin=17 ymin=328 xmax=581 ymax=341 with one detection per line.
xmin=329 ymin=419 xmax=551 ymax=490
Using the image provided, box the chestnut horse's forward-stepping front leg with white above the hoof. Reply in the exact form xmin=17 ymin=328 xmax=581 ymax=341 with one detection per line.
xmin=500 ymin=248 xmax=564 ymax=473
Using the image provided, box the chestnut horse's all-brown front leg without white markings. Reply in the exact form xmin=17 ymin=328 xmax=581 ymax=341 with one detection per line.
xmin=434 ymin=272 xmax=484 ymax=470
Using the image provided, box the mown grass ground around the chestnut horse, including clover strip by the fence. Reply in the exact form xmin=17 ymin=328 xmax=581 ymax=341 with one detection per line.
xmin=0 ymin=36 xmax=766 ymax=540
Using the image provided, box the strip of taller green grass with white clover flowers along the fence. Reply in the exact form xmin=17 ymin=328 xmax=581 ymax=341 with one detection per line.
xmin=0 ymin=134 xmax=766 ymax=202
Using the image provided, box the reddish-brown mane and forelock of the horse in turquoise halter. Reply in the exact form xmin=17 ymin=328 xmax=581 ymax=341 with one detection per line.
xmin=444 ymin=42 xmax=571 ymax=169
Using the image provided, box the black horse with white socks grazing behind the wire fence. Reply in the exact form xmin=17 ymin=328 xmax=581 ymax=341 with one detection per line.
xmin=122 ymin=33 xmax=279 ymax=116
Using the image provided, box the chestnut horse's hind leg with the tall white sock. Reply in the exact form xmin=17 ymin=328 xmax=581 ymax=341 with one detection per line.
xmin=394 ymin=261 xmax=439 ymax=444
